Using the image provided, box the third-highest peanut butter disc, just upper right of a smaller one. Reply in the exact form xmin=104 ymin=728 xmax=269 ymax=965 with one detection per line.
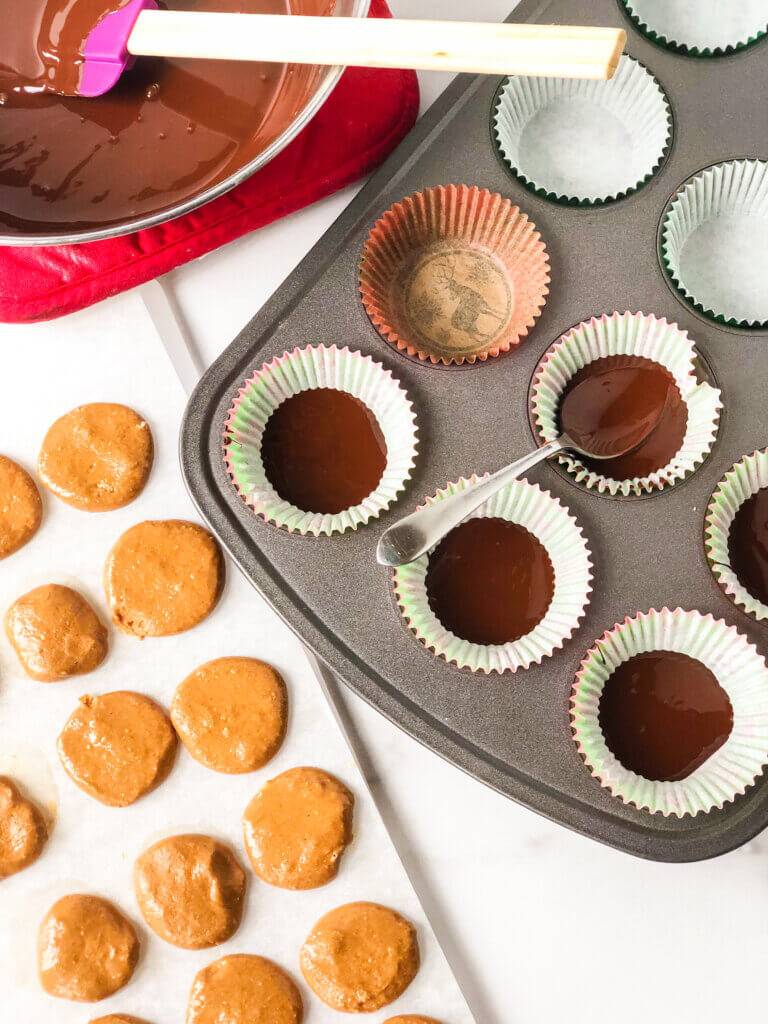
xmin=104 ymin=519 xmax=224 ymax=637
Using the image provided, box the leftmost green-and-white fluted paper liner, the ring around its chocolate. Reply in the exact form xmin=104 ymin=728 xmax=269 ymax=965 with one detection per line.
xmin=224 ymin=345 xmax=417 ymax=537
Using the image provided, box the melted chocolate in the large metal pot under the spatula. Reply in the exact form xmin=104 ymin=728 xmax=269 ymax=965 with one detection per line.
xmin=0 ymin=0 xmax=334 ymax=234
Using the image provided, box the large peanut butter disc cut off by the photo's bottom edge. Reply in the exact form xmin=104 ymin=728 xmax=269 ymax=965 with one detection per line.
xmin=186 ymin=953 xmax=303 ymax=1024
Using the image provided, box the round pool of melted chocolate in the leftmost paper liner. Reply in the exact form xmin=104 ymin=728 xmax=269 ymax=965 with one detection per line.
xmin=261 ymin=388 xmax=387 ymax=513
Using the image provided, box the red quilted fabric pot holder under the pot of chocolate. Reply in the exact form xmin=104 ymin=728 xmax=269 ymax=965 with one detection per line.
xmin=0 ymin=0 xmax=419 ymax=323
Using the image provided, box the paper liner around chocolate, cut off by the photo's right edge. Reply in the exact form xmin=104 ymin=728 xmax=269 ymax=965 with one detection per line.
xmin=705 ymin=449 xmax=768 ymax=621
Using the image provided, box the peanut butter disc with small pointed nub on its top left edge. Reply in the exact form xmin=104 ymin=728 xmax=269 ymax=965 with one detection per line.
xmin=56 ymin=690 xmax=176 ymax=807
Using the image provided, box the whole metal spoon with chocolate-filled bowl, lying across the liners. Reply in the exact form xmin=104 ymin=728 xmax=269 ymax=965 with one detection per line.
xmin=376 ymin=366 xmax=679 ymax=566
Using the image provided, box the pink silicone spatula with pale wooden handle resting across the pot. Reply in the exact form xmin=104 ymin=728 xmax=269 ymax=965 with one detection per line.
xmin=78 ymin=0 xmax=627 ymax=96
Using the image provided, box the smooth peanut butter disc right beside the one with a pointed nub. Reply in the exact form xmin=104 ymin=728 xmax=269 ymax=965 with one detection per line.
xmin=171 ymin=657 xmax=288 ymax=774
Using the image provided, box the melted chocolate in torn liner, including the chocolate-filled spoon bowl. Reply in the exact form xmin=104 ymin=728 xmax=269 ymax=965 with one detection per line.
xmin=560 ymin=355 xmax=688 ymax=480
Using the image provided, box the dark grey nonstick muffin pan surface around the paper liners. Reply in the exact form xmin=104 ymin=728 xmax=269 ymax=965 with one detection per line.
xmin=181 ymin=0 xmax=768 ymax=861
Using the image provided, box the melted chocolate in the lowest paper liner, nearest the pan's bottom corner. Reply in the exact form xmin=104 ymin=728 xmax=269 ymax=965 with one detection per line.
xmin=599 ymin=651 xmax=733 ymax=782
